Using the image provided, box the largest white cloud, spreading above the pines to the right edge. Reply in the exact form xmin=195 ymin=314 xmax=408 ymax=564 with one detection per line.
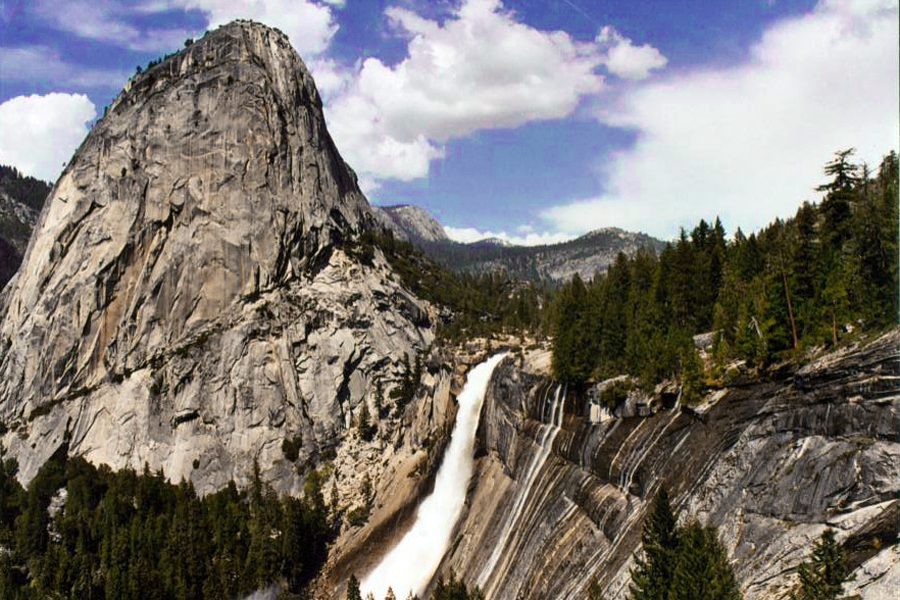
xmin=543 ymin=0 xmax=900 ymax=237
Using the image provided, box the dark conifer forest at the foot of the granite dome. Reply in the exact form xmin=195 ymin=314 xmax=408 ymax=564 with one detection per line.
xmin=0 ymin=453 xmax=331 ymax=600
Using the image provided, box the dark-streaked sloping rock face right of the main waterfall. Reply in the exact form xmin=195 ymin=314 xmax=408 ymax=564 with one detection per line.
xmin=434 ymin=332 xmax=900 ymax=600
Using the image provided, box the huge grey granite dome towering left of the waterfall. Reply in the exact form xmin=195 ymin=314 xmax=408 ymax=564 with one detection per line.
xmin=0 ymin=22 xmax=433 ymax=491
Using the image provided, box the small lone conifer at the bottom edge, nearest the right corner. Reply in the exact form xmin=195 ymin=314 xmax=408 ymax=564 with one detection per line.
xmin=791 ymin=529 xmax=853 ymax=600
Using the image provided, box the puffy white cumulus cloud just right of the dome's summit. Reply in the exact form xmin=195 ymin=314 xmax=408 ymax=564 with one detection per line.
xmin=327 ymin=0 xmax=603 ymax=184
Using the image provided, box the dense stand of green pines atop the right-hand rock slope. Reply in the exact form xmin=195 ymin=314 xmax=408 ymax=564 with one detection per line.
xmin=550 ymin=150 xmax=898 ymax=385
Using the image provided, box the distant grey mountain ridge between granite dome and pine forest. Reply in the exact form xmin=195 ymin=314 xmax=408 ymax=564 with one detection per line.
xmin=372 ymin=204 xmax=665 ymax=281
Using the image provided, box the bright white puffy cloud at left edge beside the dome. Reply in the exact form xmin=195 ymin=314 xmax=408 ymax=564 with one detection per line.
xmin=0 ymin=93 xmax=97 ymax=182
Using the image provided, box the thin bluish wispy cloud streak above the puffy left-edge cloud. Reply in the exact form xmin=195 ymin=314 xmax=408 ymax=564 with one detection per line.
xmin=0 ymin=46 xmax=128 ymax=89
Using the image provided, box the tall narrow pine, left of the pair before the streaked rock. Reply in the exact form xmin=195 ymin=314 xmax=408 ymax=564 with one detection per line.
xmin=630 ymin=486 xmax=678 ymax=600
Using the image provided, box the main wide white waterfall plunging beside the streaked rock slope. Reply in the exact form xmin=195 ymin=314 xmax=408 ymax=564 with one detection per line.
xmin=360 ymin=353 xmax=506 ymax=599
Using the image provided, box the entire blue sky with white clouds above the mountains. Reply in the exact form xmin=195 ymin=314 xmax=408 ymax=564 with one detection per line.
xmin=0 ymin=0 xmax=900 ymax=243
